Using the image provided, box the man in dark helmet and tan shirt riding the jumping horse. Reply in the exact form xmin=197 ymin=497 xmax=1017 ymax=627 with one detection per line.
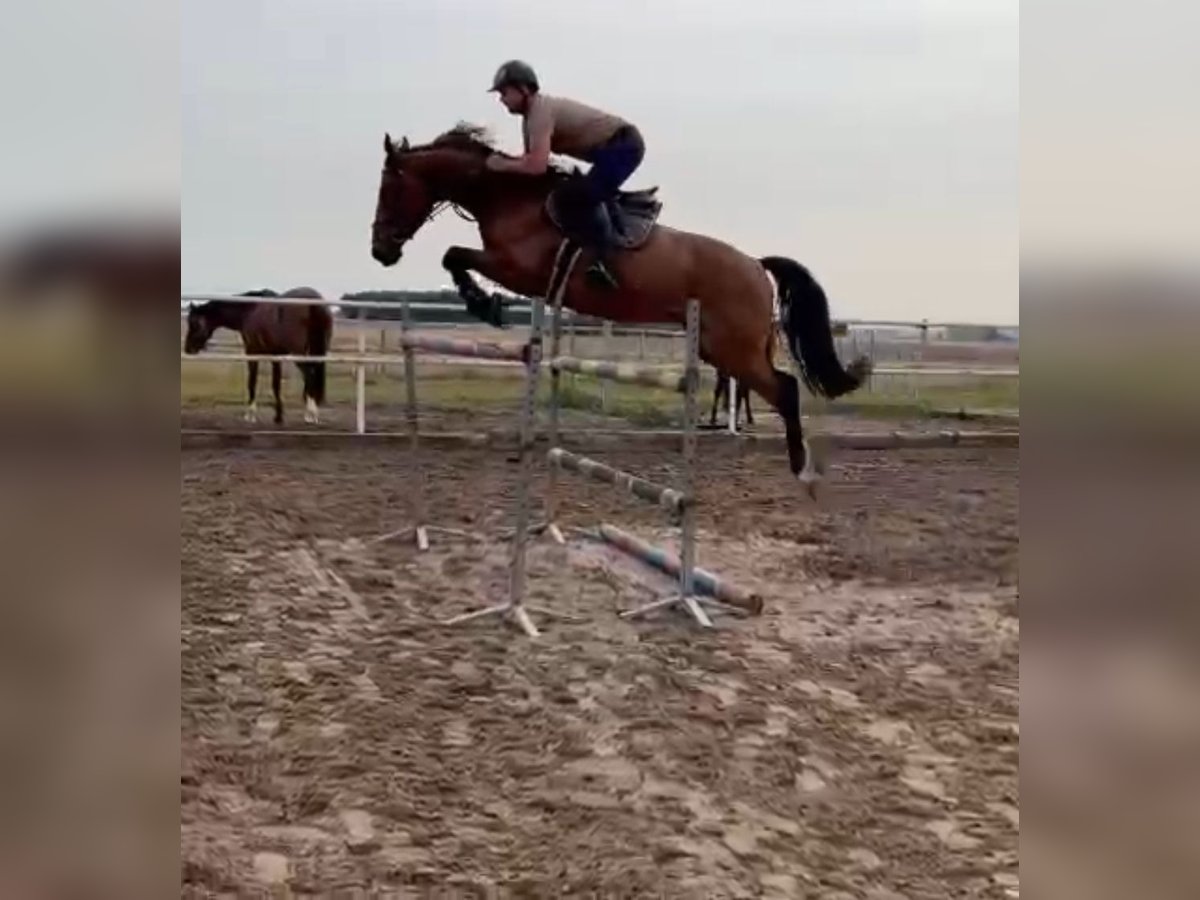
xmin=487 ymin=60 xmax=646 ymax=289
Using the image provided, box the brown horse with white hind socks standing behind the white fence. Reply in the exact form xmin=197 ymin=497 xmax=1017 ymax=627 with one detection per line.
xmin=184 ymin=288 xmax=334 ymax=425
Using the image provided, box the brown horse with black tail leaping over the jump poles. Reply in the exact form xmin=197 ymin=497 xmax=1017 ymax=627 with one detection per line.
xmin=371 ymin=125 xmax=869 ymax=492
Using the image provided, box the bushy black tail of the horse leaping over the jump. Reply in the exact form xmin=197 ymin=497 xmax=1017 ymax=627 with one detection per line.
xmin=758 ymin=257 xmax=871 ymax=400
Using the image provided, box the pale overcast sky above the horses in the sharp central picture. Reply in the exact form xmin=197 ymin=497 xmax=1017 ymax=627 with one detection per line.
xmin=180 ymin=0 xmax=1019 ymax=323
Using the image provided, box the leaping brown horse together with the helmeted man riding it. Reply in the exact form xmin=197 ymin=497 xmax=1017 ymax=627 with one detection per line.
xmin=371 ymin=70 xmax=869 ymax=492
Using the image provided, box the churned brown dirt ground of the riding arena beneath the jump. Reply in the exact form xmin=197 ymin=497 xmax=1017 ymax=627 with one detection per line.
xmin=181 ymin=427 xmax=1019 ymax=900
